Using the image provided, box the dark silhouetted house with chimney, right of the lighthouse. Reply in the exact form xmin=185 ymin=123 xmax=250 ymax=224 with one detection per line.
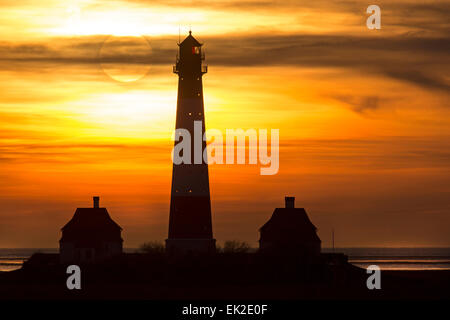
xmin=259 ymin=197 xmax=321 ymax=256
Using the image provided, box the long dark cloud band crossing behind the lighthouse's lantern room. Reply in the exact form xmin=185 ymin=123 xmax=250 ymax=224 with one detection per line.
xmin=0 ymin=33 xmax=450 ymax=92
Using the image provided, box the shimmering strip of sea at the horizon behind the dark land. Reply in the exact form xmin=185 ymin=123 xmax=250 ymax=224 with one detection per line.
xmin=0 ymin=248 xmax=450 ymax=271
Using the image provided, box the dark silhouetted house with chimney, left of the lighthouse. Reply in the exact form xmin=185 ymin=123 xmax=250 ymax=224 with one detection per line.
xmin=59 ymin=197 xmax=123 ymax=263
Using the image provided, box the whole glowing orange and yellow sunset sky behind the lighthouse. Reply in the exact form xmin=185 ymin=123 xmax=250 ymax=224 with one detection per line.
xmin=0 ymin=0 xmax=450 ymax=247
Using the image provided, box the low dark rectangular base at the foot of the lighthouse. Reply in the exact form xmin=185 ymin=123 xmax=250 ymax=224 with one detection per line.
xmin=166 ymin=239 xmax=216 ymax=255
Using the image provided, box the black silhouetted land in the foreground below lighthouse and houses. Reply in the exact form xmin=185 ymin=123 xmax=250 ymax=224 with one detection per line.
xmin=0 ymin=253 xmax=450 ymax=301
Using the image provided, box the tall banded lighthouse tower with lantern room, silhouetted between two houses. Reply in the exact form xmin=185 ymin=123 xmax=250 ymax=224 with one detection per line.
xmin=166 ymin=31 xmax=215 ymax=254
